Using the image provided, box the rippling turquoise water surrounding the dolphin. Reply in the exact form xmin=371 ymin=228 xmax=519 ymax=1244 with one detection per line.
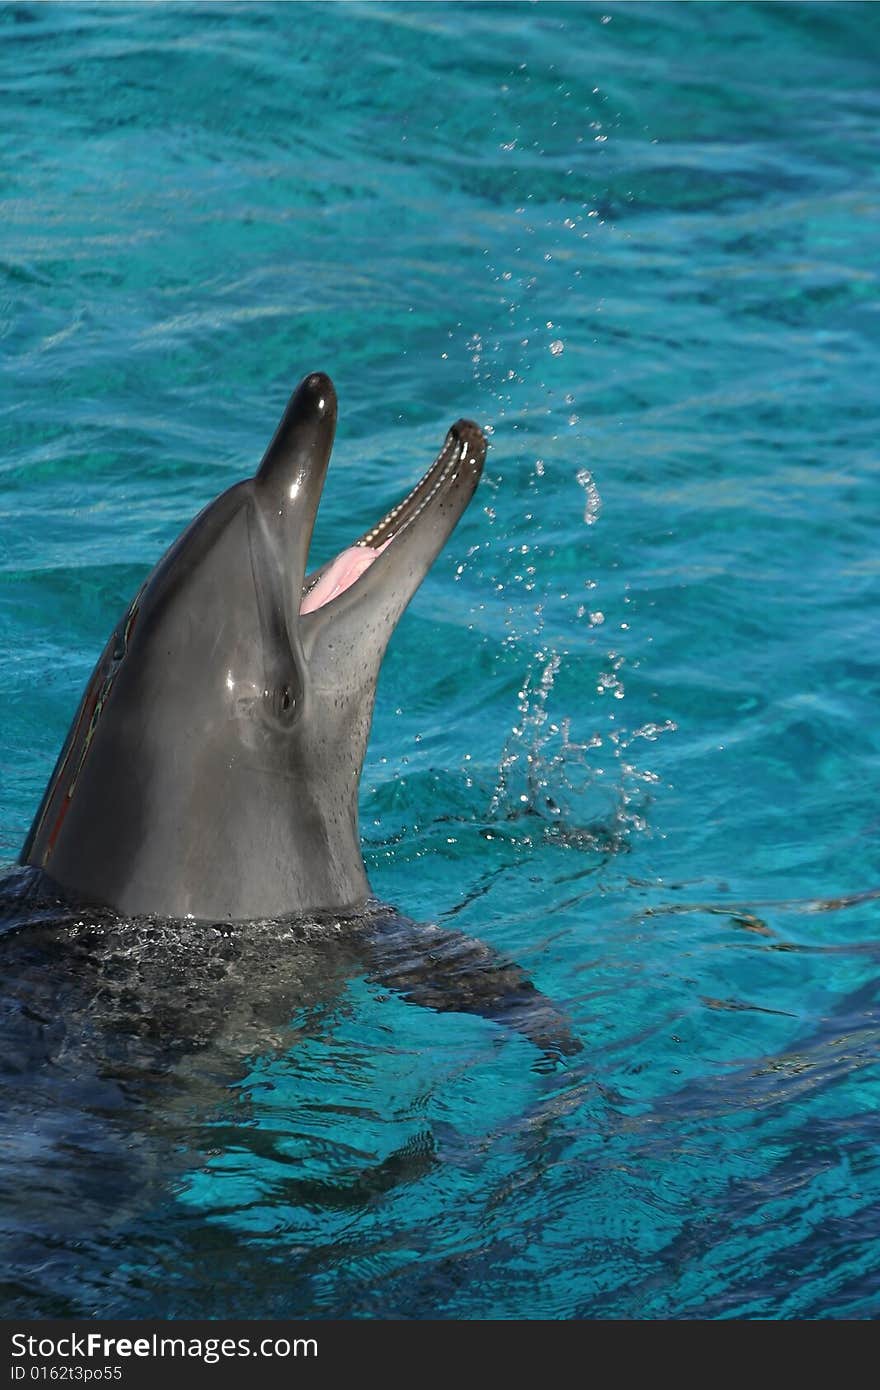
xmin=0 ymin=3 xmax=880 ymax=1318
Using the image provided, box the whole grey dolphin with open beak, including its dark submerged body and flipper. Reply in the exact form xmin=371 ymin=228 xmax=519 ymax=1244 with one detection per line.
xmin=0 ymin=374 xmax=582 ymax=1316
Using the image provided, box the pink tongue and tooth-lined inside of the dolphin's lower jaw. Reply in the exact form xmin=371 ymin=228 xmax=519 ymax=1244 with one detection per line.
xmin=300 ymin=420 xmax=487 ymax=614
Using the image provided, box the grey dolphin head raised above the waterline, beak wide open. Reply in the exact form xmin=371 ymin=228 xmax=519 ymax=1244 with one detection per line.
xmin=21 ymin=373 xmax=487 ymax=920
